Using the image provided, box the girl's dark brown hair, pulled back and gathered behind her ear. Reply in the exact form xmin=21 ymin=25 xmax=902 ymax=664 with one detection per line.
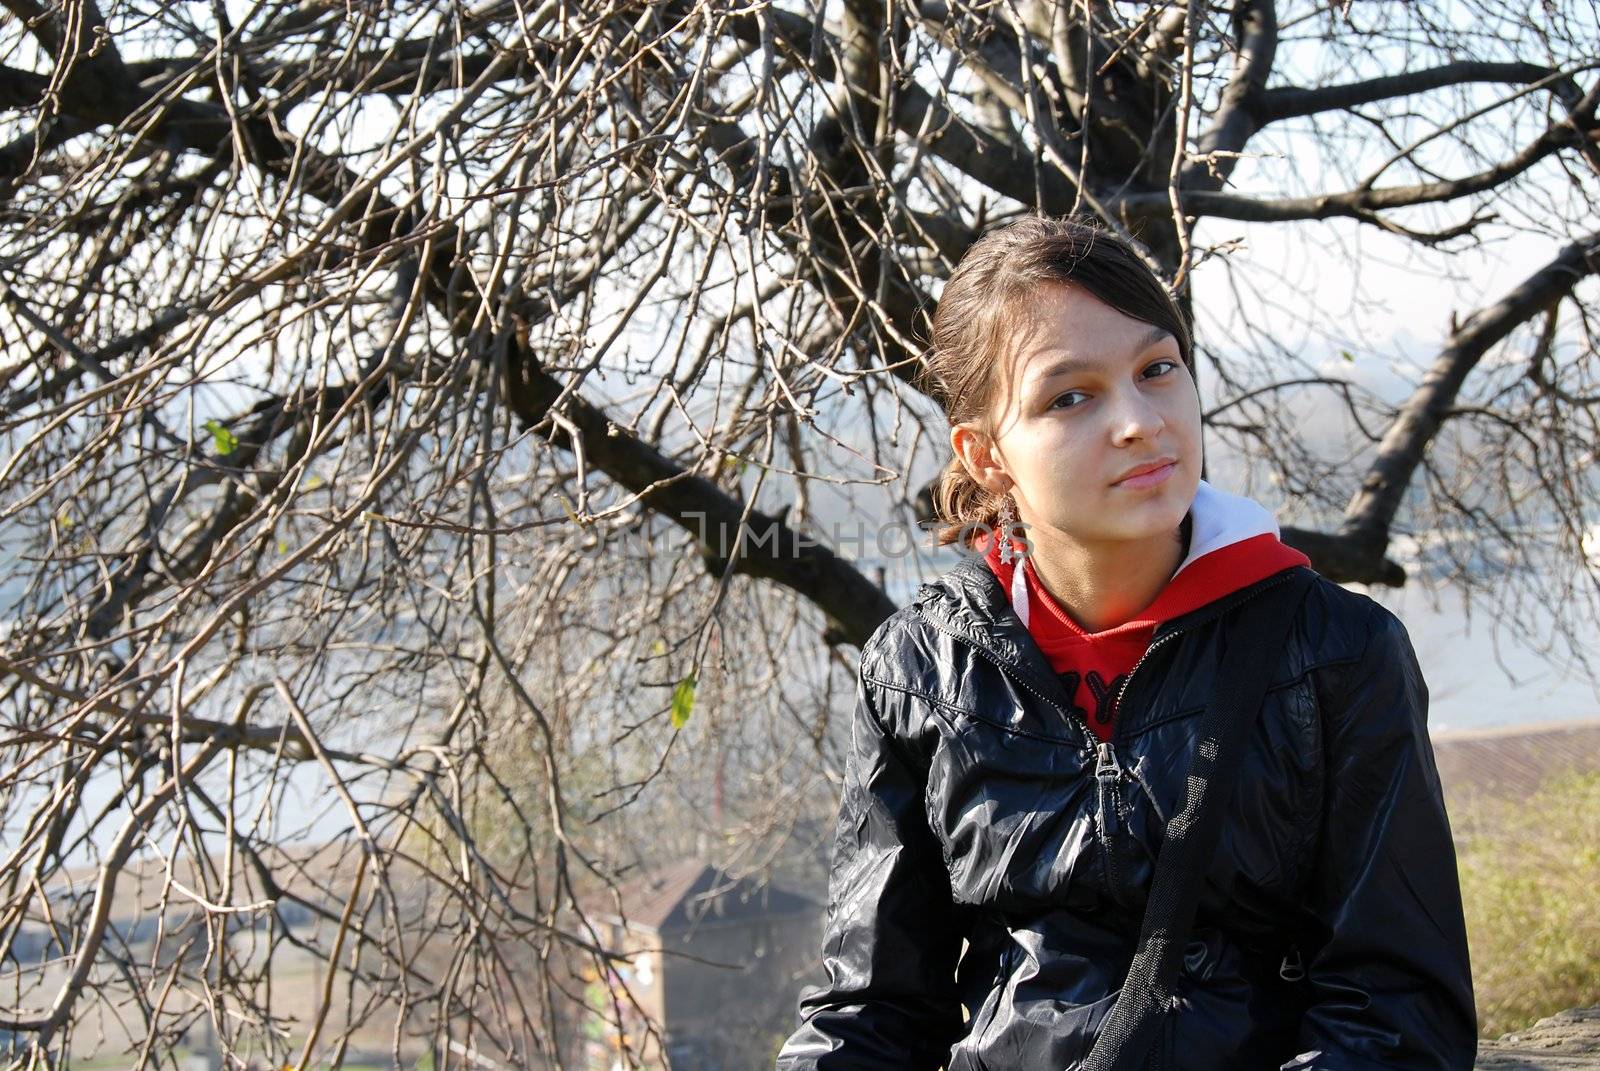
xmin=920 ymin=216 xmax=1194 ymax=546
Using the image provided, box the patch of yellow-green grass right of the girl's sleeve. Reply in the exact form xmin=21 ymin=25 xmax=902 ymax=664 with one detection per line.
xmin=1451 ymin=772 xmax=1600 ymax=1037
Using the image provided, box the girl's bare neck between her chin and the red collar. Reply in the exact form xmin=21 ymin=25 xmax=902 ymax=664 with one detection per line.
xmin=1027 ymin=525 xmax=1184 ymax=632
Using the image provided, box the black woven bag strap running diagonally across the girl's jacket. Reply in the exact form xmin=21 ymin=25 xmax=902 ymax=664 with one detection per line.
xmin=1083 ymin=567 xmax=1315 ymax=1071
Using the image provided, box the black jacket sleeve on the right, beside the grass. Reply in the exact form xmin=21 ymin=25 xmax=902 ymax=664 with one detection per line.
xmin=1282 ymin=604 xmax=1478 ymax=1071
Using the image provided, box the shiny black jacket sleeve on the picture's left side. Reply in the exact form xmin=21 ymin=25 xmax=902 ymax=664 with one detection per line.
xmin=778 ymin=659 xmax=965 ymax=1071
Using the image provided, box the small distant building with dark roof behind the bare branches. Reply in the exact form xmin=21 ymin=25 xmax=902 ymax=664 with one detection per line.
xmin=584 ymin=860 xmax=821 ymax=1071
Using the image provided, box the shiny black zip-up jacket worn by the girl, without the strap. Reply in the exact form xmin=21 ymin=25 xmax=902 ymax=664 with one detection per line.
xmin=778 ymin=556 xmax=1477 ymax=1071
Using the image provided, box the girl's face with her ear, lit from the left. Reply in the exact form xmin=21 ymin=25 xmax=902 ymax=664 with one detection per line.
xmin=950 ymin=283 xmax=1200 ymax=549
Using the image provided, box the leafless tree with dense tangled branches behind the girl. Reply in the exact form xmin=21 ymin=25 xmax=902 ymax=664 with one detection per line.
xmin=0 ymin=0 xmax=1600 ymax=1068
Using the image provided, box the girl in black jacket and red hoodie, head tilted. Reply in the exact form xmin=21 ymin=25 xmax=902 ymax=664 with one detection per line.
xmin=778 ymin=218 xmax=1477 ymax=1071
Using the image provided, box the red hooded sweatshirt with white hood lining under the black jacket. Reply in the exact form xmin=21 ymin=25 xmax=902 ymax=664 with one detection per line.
xmin=979 ymin=480 xmax=1310 ymax=740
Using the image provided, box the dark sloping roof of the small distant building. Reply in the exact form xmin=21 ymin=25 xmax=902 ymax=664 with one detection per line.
xmin=584 ymin=860 xmax=816 ymax=933
